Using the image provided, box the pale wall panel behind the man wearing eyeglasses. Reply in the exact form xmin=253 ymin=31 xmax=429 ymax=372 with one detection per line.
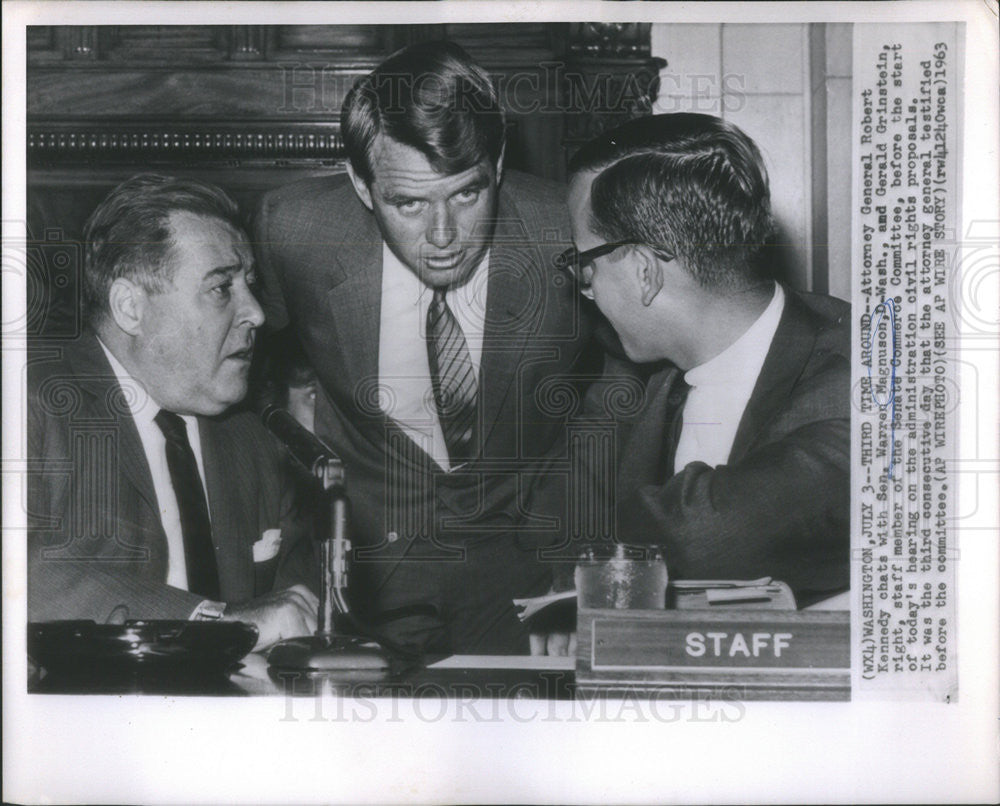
xmin=651 ymin=23 xmax=852 ymax=300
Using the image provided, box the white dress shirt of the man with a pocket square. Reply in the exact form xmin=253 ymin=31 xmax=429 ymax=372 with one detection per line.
xmin=98 ymin=339 xmax=208 ymax=590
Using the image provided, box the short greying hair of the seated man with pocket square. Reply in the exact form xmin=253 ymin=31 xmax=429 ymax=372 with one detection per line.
xmin=83 ymin=174 xmax=242 ymax=324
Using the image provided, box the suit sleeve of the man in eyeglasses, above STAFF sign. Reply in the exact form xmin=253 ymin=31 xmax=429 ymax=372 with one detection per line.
xmin=618 ymin=361 xmax=850 ymax=603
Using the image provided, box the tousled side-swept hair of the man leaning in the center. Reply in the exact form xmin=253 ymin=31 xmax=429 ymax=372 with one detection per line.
xmin=340 ymin=41 xmax=504 ymax=185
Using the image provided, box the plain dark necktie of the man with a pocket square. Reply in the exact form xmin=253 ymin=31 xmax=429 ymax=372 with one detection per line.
xmin=155 ymin=409 xmax=219 ymax=599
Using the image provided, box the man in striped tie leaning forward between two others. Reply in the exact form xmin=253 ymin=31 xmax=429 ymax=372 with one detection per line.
xmin=255 ymin=42 xmax=591 ymax=654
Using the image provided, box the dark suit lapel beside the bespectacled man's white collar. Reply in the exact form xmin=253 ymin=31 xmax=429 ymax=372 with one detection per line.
xmin=729 ymin=288 xmax=816 ymax=462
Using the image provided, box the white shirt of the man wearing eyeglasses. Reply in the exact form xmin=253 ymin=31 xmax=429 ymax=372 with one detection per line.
xmin=674 ymin=283 xmax=785 ymax=473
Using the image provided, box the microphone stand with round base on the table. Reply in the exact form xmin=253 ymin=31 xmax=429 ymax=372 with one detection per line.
xmin=267 ymin=455 xmax=390 ymax=682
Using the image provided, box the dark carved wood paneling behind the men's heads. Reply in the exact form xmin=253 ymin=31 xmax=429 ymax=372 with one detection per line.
xmin=27 ymin=23 xmax=664 ymax=335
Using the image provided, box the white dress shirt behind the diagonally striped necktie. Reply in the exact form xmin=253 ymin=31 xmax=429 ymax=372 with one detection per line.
xmin=378 ymin=243 xmax=490 ymax=470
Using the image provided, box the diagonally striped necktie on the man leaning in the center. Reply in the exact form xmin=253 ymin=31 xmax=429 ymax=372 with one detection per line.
xmin=427 ymin=288 xmax=478 ymax=465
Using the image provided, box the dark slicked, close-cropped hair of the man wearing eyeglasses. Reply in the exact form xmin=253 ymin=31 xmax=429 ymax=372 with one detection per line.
xmin=570 ymin=113 xmax=774 ymax=288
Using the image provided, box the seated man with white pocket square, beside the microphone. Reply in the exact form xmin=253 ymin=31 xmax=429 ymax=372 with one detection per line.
xmin=28 ymin=175 xmax=318 ymax=647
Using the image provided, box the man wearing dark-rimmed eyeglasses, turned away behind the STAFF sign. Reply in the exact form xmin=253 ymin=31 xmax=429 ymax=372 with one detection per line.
xmin=557 ymin=114 xmax=850 ymax=605
